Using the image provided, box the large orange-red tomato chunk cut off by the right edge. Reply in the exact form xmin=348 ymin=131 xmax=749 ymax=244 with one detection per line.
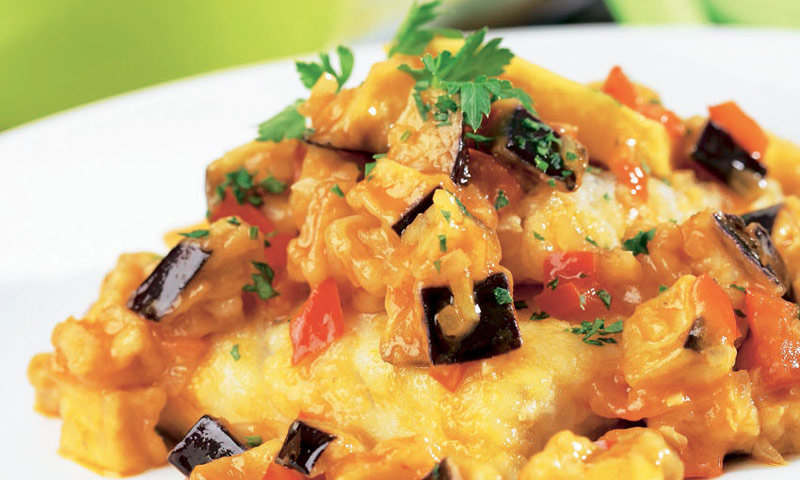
xmin=740 ymin=289 xmax=800 ymax=387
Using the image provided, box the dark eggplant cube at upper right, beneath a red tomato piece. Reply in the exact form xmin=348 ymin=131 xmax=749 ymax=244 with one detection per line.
xmin=691 ymin=120 xmax=767 ymax=196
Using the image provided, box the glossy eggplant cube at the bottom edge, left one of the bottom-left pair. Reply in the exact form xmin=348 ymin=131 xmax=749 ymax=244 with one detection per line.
xmin=167 ymin=415 xmax=245 ymax=477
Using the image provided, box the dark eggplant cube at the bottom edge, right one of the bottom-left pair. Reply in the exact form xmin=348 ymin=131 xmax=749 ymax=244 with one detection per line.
xmin=275 ymin=420 xmax=336 ymax=475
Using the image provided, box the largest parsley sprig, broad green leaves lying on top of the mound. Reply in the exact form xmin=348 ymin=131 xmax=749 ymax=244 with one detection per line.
xmin=398 ymin=28 xmax=533 ymax=130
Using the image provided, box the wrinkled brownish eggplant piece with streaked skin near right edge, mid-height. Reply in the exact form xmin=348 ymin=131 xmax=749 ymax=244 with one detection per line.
xmin=713 ymin=212 xmax=791 ymax=293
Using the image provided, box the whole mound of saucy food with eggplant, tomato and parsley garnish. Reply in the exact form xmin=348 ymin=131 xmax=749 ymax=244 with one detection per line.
xmin=29 ymin=2 xmax=800 ymax=480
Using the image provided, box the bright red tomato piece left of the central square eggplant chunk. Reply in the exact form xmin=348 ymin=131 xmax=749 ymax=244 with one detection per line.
xmin=289 ymin=277 xmax=344 ymax=364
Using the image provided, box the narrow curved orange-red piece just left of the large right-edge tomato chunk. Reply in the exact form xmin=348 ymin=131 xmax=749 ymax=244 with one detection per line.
xmin=692 ymin=274 xmax=738 ymax=345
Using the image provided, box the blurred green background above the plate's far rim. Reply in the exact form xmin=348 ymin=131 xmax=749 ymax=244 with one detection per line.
xmin=0 ymin=0 xmax=800 ymax=130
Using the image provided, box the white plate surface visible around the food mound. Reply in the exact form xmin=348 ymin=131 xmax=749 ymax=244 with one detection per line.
xmin=0 ymin=26 xmax=800 ymax=480
